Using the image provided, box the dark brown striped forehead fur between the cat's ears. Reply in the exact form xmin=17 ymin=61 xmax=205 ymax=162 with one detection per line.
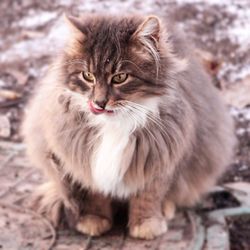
xmin=83 ymin=17 xmax=139 ymax=72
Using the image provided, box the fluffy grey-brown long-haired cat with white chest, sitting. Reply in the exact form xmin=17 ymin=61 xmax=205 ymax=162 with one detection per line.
xmin=23 ymin=15 xmax=235 ymax=239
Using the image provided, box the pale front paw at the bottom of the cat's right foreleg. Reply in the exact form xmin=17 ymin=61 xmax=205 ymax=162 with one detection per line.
xmin=129 ymin=217 xmax=167 ymax=240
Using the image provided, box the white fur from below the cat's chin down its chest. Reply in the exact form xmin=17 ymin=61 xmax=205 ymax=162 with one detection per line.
xmin=91 ymin=99 xmax=158 ymax=198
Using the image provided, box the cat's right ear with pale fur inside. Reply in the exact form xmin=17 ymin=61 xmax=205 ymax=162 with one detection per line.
xmin=133 ymin=16 xmax=161 ymax=47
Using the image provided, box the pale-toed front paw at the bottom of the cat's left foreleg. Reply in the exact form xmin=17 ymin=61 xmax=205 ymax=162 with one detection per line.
xmin=76 ymin=214 xmax=112 ymax=236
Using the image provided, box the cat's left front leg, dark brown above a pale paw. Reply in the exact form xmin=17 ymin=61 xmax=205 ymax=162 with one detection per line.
xmin=76 ymin=193 xmax=113 ymax=236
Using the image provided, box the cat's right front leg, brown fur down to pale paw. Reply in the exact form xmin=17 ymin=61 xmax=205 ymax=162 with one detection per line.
xmin=129 ymin=180 xmax=167 ymax=240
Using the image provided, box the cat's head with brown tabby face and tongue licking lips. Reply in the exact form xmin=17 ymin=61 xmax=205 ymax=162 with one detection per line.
xmin=56 ymin=15 xmax=185 ymax=128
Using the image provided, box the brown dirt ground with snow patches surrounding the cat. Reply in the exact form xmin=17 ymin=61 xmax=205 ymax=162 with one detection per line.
xmin=0 ymin=0 xmax=250 ymax=250
